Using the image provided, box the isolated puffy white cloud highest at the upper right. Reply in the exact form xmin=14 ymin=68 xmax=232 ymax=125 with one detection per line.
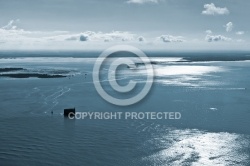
xmin=202 ymin=3 xmax=229 ymax=15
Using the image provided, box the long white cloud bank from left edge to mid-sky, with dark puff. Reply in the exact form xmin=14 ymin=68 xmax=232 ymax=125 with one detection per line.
xmin=0 ymin=20 xmax=136 ymax=44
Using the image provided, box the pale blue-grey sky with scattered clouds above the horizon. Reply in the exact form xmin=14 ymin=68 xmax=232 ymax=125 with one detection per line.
xmin=0 ymin=0 xmax=250 ymax=50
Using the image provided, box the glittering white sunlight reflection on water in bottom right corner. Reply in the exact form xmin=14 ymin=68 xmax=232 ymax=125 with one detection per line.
xmin=142 ymin=129 xmax=249 ymax=166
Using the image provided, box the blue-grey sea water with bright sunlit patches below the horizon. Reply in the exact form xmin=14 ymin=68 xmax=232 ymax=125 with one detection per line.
xmin=0 ymin=53 xmax=250 ymax=166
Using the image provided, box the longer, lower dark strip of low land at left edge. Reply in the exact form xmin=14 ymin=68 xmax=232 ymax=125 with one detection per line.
xmin=0 ymin=73 xmax=67 ymax=78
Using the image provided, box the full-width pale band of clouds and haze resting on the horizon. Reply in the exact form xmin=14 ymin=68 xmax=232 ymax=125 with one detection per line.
xmin=0 ymin=20 xmax=249 ymax=50
